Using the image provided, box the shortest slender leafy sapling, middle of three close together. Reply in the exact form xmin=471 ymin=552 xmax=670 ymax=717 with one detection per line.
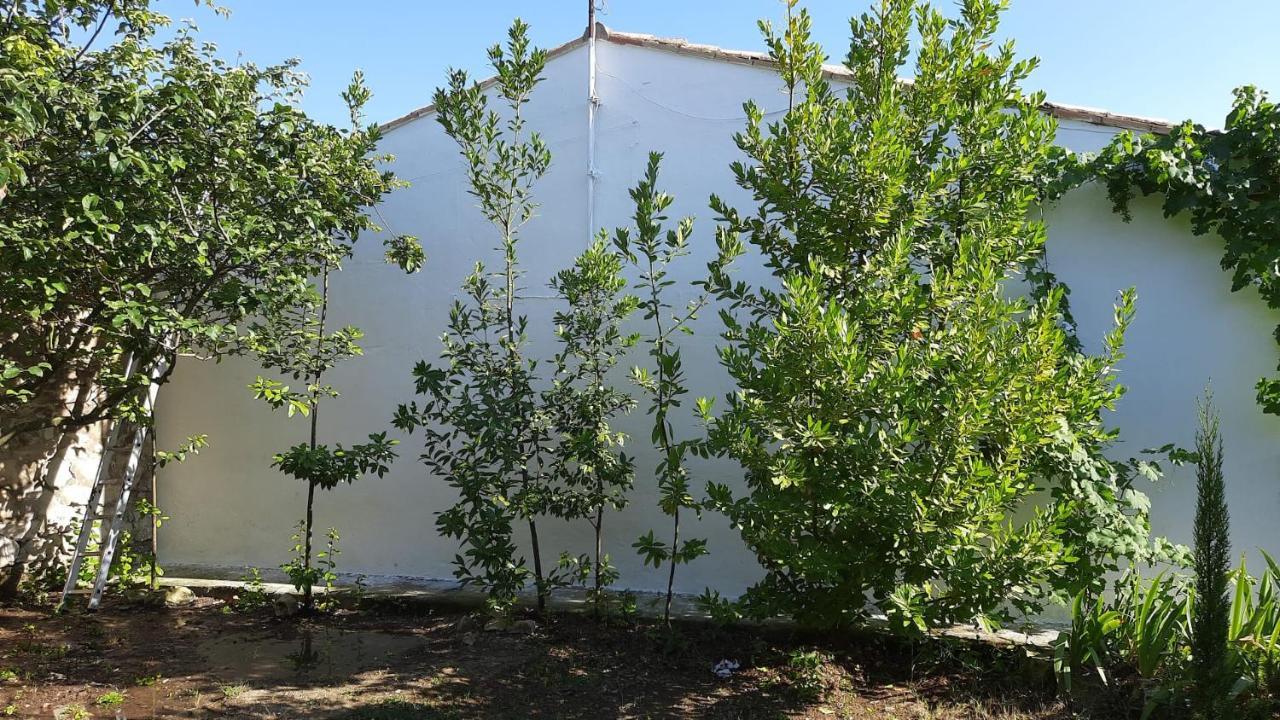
xmin=543 ymin=237 xmax=639 ymax=616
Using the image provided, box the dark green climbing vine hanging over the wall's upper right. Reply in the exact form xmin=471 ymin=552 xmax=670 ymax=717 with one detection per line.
xmin=1056 ymin=86 xmax=1280 ymax=415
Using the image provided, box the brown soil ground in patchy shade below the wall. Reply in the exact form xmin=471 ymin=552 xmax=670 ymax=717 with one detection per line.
xmin=0 ymin=597 xmax=1073 ymax=720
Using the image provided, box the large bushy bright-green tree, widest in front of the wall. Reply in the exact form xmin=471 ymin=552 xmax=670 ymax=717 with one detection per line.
xmin=708 ymin=0 xmax=1149 ymax=629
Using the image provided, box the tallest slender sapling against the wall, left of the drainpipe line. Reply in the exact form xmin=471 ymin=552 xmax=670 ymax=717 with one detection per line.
xmin=394 ymin=19 xmax=557 ymax=612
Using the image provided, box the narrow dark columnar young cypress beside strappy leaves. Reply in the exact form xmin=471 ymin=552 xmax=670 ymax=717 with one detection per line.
xmin=1190 ymin=393 xmax=1231 ymax=719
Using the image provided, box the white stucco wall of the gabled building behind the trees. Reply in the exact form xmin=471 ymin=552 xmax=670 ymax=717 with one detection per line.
xmin=157 ymin=35 xmax=1280 ymax=594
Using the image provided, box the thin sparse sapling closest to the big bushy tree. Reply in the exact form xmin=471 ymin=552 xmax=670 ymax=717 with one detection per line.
xmin=613 ymin=152 xmax=727 ymax=625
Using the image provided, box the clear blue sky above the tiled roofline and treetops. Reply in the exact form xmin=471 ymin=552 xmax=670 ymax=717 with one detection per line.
xmin=159 ymin=0 xmax=1280 ymax=127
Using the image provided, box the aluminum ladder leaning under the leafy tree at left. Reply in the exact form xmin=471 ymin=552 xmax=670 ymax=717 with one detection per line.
xmin=58 ymin=355 xmax=169 ymax=610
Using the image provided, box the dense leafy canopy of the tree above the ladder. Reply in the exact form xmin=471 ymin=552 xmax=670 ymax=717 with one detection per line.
xmin=0 ymin=0 xmax=420 ymax=442
